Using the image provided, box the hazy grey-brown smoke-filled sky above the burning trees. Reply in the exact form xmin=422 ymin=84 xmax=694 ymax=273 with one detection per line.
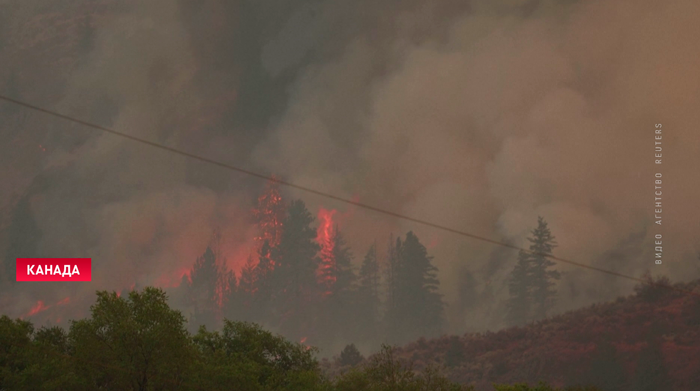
xmin=0 ymin=0 xmax=700 ymax=330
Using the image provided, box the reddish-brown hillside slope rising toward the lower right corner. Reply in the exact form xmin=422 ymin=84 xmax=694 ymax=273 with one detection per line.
xmin=327 ymin=278 xmax=700 ymax=391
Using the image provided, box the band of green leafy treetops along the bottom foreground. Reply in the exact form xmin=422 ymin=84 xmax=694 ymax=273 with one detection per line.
xmin=0 ymin=288 xmax=620 ymax=391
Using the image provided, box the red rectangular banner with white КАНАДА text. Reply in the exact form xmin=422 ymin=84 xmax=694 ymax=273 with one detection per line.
xmin=17 ymin=258 xmax=92 ymax=281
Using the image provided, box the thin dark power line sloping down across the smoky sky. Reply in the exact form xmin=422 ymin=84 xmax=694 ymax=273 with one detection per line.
xmin=0 ymin=95 xmax=700 ymax=296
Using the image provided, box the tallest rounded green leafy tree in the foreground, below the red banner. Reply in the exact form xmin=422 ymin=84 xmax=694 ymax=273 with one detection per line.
xmin=69 ymin=288 xmax=193 ymax=390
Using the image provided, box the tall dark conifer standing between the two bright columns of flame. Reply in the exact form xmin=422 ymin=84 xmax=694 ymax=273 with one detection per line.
xmin=271 ymin=200 xmax=320 ymax=339
